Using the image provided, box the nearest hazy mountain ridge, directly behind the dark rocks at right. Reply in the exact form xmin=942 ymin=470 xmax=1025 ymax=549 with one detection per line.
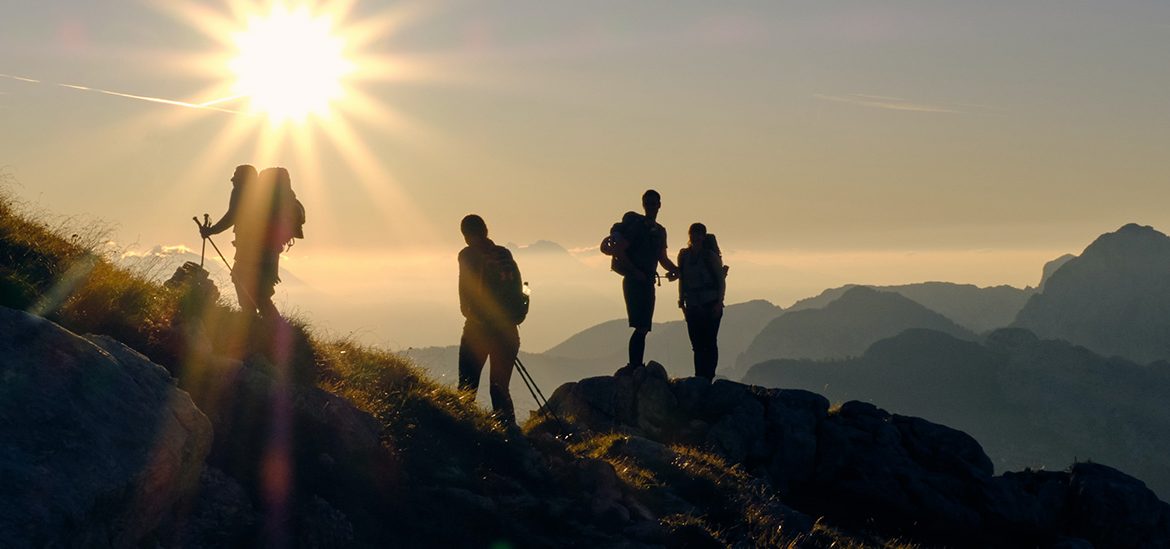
xmin=744 ymin=328 xmax=1170 ymax=497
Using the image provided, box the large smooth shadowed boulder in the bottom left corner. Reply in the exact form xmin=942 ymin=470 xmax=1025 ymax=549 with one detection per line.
xmin=0 ymin=308 xmax=212 ymax=547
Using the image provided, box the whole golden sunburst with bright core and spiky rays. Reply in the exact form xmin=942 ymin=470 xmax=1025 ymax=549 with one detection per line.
xmin=138 ymin=0 xmax=484 ymax=252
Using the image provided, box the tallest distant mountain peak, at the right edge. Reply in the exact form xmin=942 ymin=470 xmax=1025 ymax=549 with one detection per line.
xmin=1012 ymin=224 xmax=1170 ymax=363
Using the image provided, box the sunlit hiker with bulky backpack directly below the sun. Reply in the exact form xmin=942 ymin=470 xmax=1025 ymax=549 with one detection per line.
xmin=199 ymin=164 xmax=304 ymax=318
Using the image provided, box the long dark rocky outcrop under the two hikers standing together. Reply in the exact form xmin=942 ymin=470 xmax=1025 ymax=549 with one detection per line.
xmin=549 ymin=363 xmax=1170 ymax=548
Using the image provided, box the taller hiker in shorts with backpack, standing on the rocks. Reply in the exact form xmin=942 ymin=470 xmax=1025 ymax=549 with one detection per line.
xmin=601 ymin=190 xmax=679 ymax=376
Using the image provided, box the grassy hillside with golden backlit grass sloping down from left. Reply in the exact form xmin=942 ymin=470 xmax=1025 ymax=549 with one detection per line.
xmin=0 ymin=181 xmax=892 ymax=547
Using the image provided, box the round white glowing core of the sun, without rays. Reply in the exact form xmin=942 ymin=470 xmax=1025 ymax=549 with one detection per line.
xmin=229 ymin=6 xmax=355 ymax=123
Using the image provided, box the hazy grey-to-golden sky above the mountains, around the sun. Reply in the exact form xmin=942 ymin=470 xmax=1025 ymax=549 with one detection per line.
xmin=0 ymin=0 xmax=1170 ymax=346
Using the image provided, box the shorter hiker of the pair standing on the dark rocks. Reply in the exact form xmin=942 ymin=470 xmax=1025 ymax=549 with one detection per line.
xmin=679 ymin=224 xmax=727 ymax=379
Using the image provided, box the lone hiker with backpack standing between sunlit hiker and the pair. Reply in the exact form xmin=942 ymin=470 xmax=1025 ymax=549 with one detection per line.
xmin=459 ymin=214 xmax=528 ymax=425
